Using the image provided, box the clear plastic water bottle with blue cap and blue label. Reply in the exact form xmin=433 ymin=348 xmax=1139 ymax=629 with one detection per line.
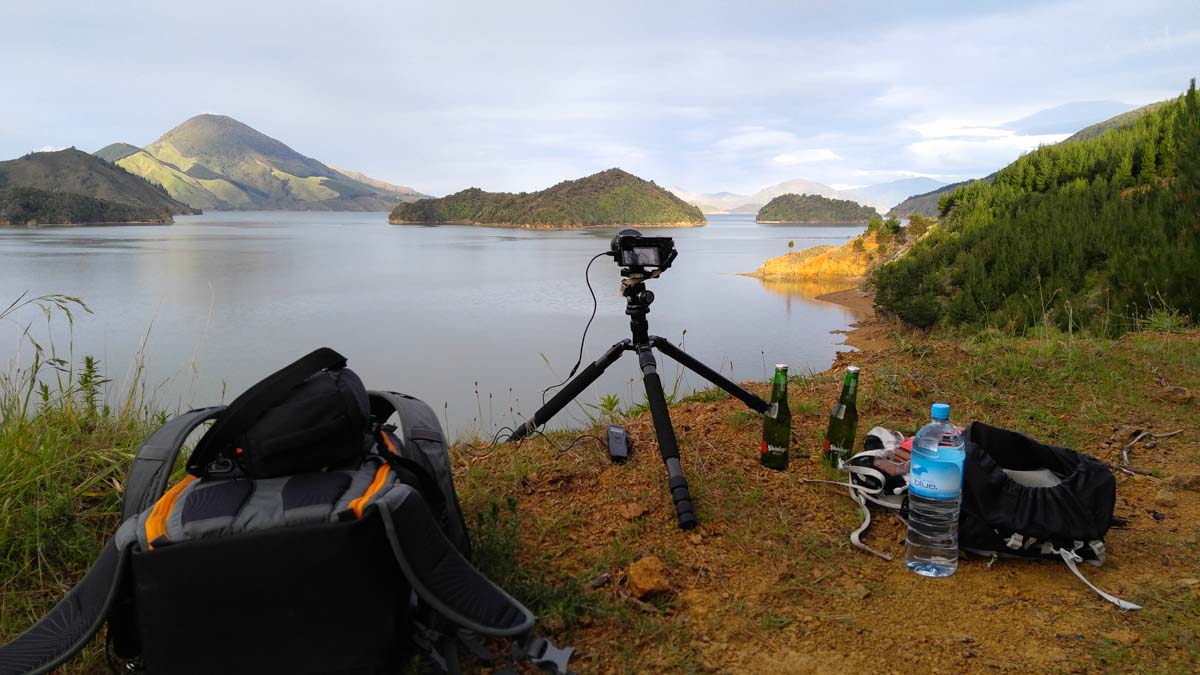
xmin=905 ymin=404 xmax=966 ymax=577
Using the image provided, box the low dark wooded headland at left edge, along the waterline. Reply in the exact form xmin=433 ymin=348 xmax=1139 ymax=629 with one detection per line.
xmin=0 ymin=187 xmax=172 ymax=227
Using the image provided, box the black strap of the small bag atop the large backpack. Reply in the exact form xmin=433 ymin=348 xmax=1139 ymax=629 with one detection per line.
xmin=187 ymin=347 xmax=346 ymax=476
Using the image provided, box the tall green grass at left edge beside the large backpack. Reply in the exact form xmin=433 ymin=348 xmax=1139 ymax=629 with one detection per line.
xmin=0 ymin=290 xmax=164 ymax=670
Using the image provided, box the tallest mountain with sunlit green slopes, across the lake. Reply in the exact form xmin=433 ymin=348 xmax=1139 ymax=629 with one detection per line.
xmin=96 ymin=114 xmax=418 ymax=211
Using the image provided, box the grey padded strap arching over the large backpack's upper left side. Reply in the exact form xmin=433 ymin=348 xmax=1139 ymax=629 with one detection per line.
xmin=121 ymin=406 xmax=224 ymax=522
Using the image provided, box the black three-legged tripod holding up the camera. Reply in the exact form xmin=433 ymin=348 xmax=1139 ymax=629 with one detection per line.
xmin=509 ymin=279 xmax=770 ymax=530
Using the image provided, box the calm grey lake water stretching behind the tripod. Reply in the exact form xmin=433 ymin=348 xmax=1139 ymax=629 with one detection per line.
xmin=0 ymin=211 xmax=863 ymax=436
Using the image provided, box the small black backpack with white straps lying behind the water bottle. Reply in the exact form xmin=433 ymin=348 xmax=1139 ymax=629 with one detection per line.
xmin=818 ymin=422 xmax=1141 ymax=609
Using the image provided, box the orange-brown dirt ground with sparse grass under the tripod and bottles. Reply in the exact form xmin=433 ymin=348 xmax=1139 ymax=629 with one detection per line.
xmin=458 ymin=291 xmax=1200 ymax=673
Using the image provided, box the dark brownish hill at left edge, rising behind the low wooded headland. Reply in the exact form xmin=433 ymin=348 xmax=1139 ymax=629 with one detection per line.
xmin=0 ymin=148 xmax=199 ymax=216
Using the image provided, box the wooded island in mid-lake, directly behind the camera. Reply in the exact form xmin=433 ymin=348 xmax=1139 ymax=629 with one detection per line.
xmin=388 ymin=168 xmax=704 ymax=229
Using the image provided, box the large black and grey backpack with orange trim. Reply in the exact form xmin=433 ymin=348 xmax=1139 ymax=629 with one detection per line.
xmin=0 ymin=348 xmax=571 ymax=675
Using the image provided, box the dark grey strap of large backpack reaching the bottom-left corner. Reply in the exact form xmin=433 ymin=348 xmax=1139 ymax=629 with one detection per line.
xmin=0 ymin=540 xmax=130 ymax=675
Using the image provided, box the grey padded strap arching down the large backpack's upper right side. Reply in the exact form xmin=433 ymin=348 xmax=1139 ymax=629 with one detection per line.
xmin=367 ymin=390 xmax=470 ymax=558
